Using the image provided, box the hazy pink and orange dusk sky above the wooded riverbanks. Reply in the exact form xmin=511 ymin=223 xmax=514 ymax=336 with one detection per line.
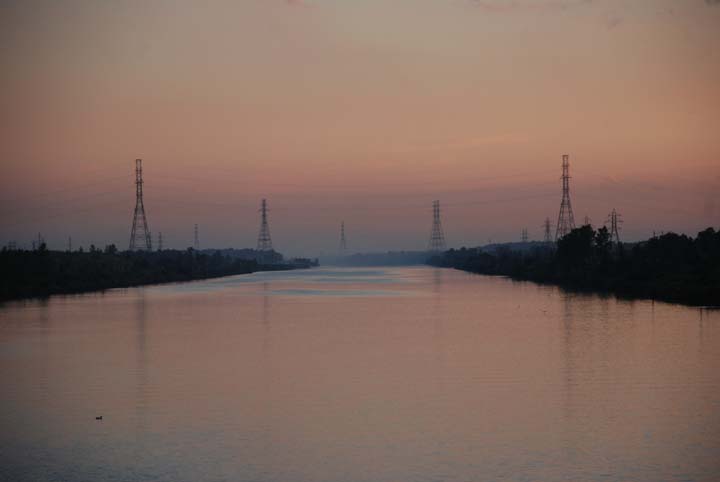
xmin=0 ymin=0 xmax=720 ymax=255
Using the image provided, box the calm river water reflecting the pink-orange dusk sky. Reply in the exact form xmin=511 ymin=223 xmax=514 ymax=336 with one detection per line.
xmin=0 ymin=268 xmax=720 ymax=482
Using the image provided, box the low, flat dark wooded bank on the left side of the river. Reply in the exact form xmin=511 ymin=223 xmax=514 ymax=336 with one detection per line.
xmin=0 ymin=245 xmax=266 ymax=300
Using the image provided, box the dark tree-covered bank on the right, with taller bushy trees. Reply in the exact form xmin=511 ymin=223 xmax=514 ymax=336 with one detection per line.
xmin=428 ymin=226 xmax=720 ymax=306
